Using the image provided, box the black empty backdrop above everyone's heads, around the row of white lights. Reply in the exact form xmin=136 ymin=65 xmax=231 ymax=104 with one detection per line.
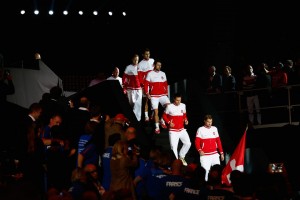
xmin=0 ymin=0 xmax=300 ymax=82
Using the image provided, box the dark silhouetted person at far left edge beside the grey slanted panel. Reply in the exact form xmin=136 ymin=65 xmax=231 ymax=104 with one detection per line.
xmin=0 ymin=68 xmax=15 ymax=106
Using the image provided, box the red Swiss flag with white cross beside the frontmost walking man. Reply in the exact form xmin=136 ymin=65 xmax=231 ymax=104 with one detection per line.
xmin=222 ymin=130 xmax=247 ymax=186
